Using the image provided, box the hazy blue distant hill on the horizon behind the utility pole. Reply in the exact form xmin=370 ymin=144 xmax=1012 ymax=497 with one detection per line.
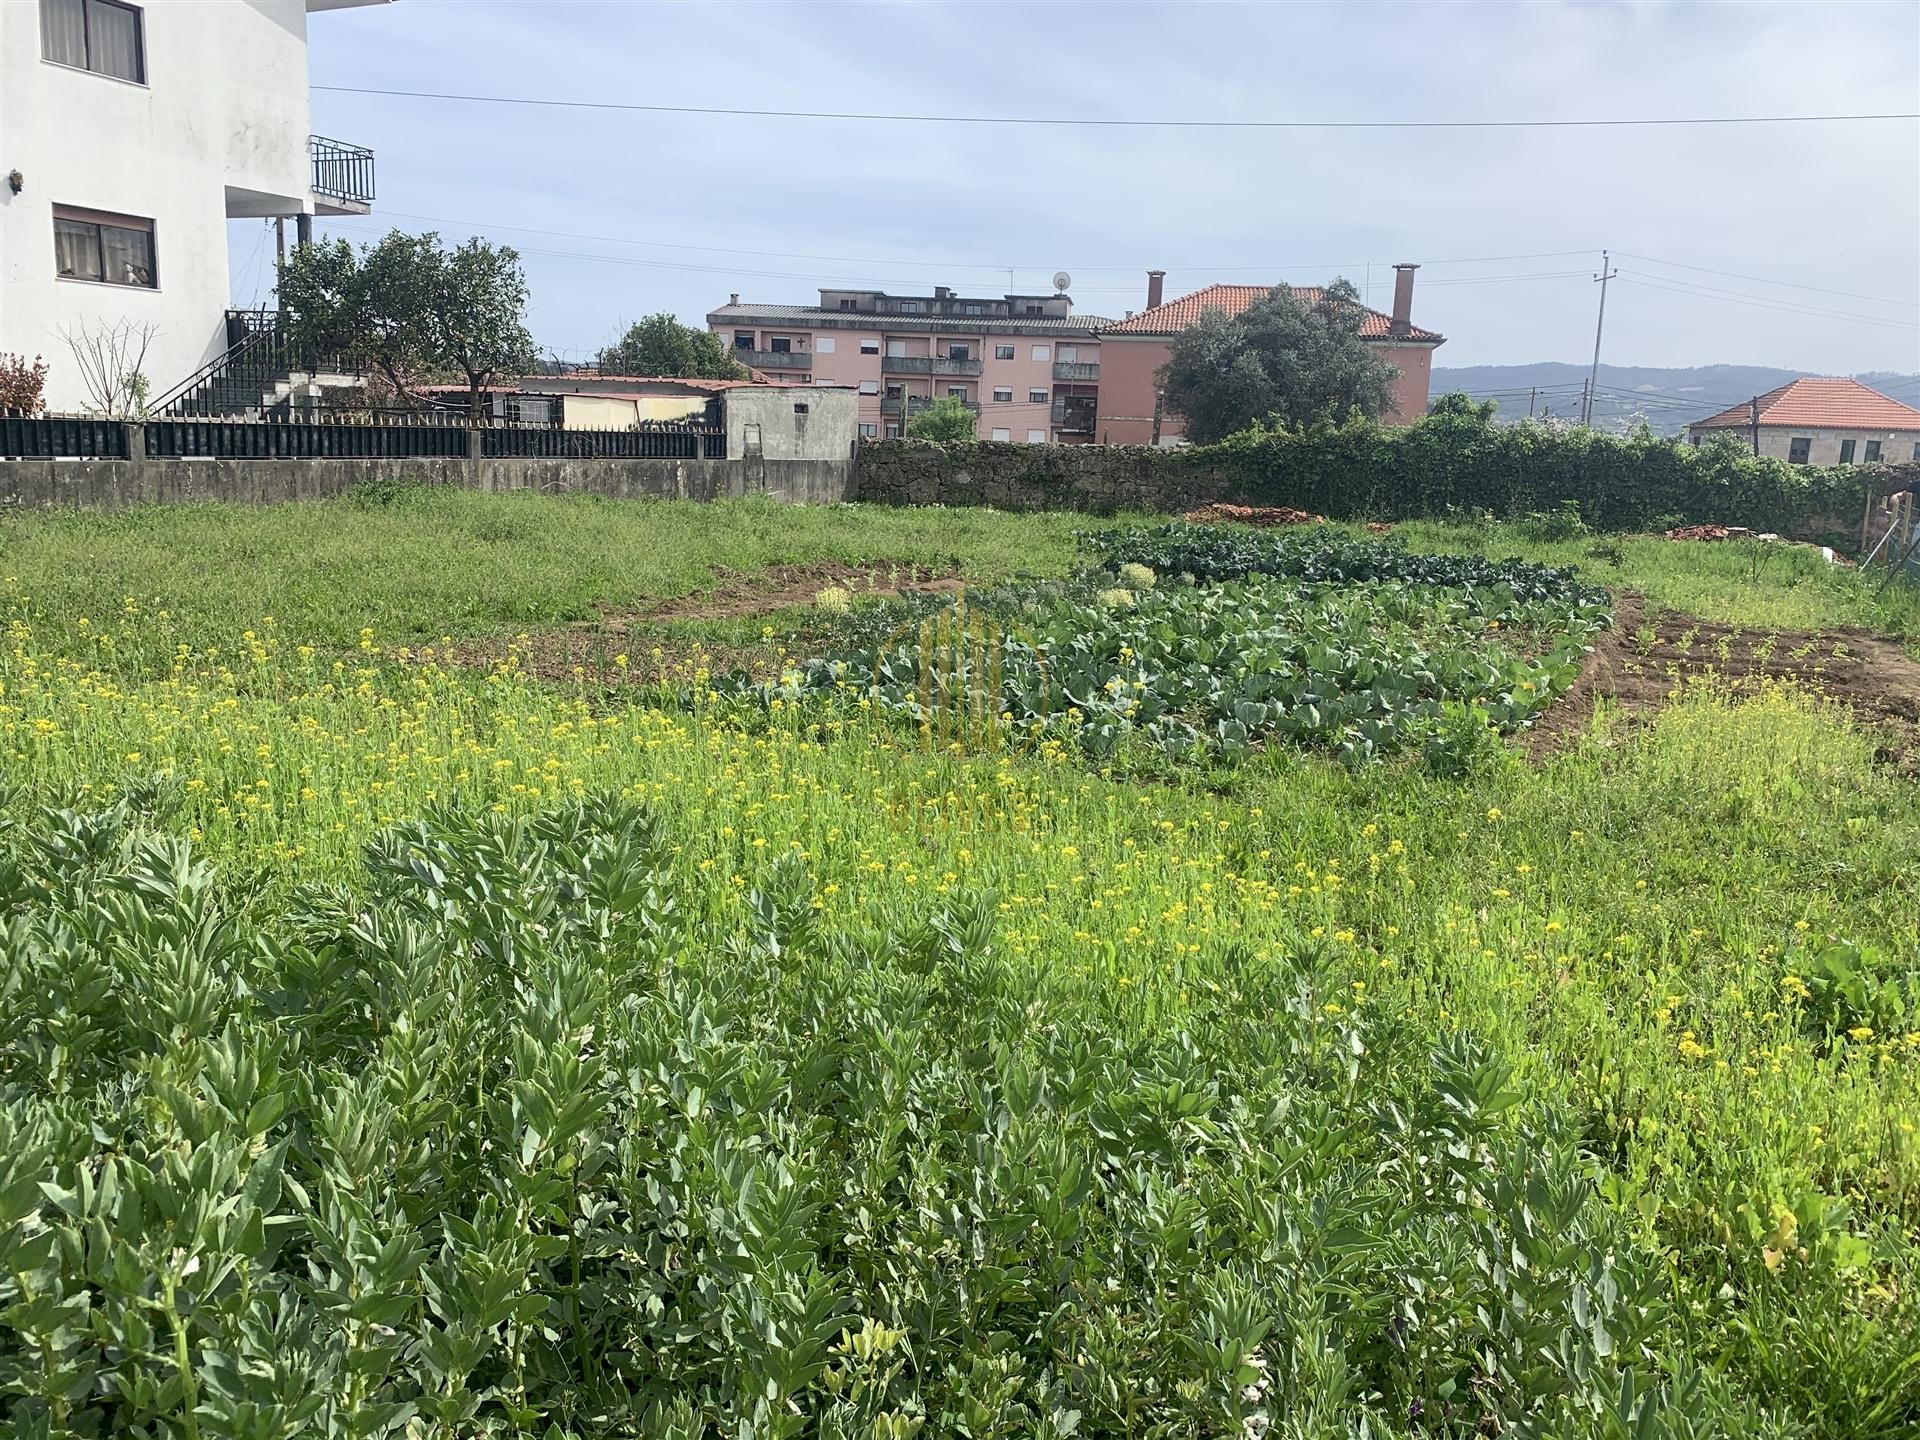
xmin=1432 ymin=361 xmax=1920 ymax=434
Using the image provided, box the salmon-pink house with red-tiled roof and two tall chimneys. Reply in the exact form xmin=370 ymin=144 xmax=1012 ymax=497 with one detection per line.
xmin=1096 ymin=265 xmax=1446 ymax=445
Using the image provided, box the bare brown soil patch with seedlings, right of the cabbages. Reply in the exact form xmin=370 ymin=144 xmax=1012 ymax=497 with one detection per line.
xmin=1526 ymin=591 xmax=1920 ymax=760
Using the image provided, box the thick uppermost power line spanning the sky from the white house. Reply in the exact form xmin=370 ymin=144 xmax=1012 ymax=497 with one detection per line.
xmin=311 ymin=84 xmax=1920 ymax=131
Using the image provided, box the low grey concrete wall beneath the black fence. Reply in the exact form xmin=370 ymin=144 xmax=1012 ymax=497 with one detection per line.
xmin=0 ymin=457 xmax=852 ymax=507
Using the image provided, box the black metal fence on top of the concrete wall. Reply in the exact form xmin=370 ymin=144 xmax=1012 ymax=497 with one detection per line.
xmin=0 ymin=413 xmax=728 ymax=461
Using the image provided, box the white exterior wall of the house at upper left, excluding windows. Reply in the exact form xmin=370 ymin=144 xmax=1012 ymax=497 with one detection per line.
xmin=0 ymin=0 xmax=337 ymax=411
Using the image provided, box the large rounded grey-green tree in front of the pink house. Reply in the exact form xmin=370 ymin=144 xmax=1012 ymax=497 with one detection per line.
xmin=1156 ymin=280 xmax=1400 ymax=444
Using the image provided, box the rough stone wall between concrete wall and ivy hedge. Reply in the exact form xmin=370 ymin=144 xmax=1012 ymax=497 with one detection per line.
xmin=852 ymin=440 xmax=1248 ymax=515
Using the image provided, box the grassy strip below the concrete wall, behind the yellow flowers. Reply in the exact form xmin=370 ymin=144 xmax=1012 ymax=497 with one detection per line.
xmin=0 ymin=492 xmax=1085 ymax=645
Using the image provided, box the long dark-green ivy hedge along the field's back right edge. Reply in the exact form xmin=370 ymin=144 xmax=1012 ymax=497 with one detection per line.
xmin=1188 ymin=396 xmax=1870 ymax=538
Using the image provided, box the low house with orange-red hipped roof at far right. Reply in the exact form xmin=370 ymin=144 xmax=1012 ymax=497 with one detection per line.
xmin=1686 ymin=380 xmax=1920 ymax=465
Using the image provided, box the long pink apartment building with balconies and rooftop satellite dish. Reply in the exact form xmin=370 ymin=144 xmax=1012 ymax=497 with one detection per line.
xmin=707 ymin=286 xmax=1112 ymax=444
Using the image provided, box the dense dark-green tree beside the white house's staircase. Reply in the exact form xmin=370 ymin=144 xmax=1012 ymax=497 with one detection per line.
xmin=280 ymin=230 xmax=534 ymax=417
